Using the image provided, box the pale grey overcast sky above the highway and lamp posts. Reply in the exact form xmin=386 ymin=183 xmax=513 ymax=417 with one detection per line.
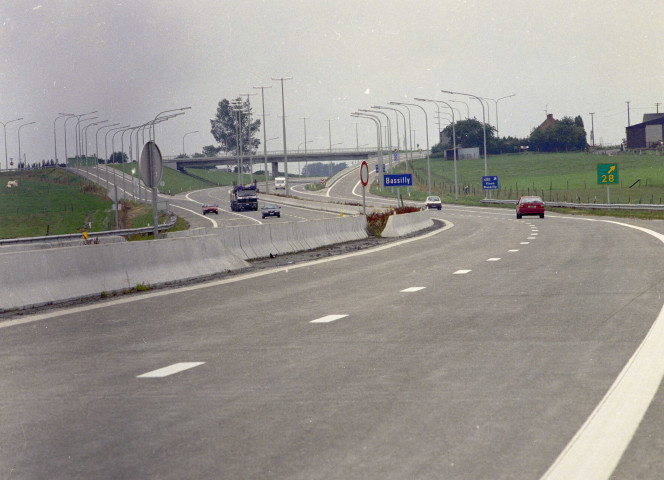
xmin=0 ymin=0 xmax=664 ymax=164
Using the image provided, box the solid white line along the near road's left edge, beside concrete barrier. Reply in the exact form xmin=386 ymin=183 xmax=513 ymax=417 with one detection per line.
xmin=0 ymin=219 xmax=454 ymax=329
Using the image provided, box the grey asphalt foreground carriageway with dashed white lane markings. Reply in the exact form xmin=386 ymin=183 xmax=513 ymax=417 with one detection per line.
xmin=0 ymin=198 xmax=664 ymax=479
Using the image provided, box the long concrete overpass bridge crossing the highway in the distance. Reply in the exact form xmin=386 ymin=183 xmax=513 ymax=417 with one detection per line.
xmin=163 ymin=148 xmax=378 ymax=178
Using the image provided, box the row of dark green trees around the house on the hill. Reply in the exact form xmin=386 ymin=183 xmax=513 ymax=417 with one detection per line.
xmin=432 ymin=116 xmax=588 ymax=154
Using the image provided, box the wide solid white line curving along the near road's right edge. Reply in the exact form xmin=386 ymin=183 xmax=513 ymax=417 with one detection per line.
xmin=541 ymin=217 xmax=664 ymax=480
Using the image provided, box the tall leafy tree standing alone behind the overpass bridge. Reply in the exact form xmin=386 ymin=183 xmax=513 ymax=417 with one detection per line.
xmin=210 ymin=97 xmax=261 ymax=153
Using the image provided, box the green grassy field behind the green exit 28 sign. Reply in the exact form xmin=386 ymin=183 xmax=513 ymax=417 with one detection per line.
xmin=373 ymin=153 xmax=664 ymax=204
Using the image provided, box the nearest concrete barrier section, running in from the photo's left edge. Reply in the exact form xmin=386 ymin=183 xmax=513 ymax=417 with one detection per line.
xmin=0 ymin=235 xmax=249 ymax=312
